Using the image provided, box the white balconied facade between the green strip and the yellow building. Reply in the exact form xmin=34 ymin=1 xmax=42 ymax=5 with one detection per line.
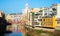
xmin=34 ymin=8 xmax=47 ymax=26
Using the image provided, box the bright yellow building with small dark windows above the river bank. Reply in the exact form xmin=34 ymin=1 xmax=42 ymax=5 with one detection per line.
xmin=42 ymin=16 xmax=56 ymax=28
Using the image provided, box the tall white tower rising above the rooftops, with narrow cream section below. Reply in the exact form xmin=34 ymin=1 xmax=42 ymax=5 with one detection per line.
xmin=22 ymin=3 xmax=30 ymax=25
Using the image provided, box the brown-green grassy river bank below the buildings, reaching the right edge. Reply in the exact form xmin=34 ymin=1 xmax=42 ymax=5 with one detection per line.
xmin=27 ymin=28 xmax=60 ymax=36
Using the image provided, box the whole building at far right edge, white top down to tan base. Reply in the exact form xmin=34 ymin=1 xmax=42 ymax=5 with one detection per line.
xmin=51 ymin=4 xmax=60 ymax=26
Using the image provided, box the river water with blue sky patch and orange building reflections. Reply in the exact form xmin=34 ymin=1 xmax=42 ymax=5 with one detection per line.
xmin=5 ymin=24 xmax=26 ymax=36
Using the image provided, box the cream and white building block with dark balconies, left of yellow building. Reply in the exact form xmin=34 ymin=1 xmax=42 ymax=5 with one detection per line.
xmin=29 ymin=8 xmax=47 ymax=27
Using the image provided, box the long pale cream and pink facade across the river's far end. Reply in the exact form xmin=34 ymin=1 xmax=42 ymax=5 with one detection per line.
xmin=6 ymin=14 xmax=22 ymax=24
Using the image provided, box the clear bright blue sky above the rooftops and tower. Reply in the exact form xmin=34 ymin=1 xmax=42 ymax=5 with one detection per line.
xmin=0 ymin=0 xmax=60 ymax=14
